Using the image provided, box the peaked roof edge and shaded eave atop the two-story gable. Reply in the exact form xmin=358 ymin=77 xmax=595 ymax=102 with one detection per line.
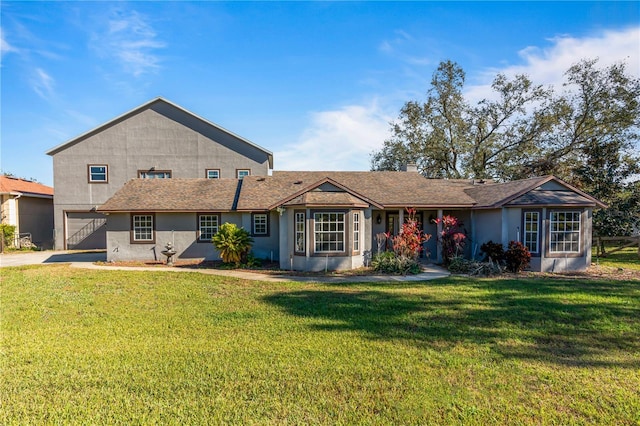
xmin=47 ymin=97 xmax=273 ymax=168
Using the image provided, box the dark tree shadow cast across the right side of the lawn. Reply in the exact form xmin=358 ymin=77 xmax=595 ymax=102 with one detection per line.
xmin=264 ymin=279 xmax=640 ymax=368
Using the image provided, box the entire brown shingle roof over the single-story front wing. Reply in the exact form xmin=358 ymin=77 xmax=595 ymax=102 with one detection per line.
xmin=98 ymin=172 xmax=604 ymax=212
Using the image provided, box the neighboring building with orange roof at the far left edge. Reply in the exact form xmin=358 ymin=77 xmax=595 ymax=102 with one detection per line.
xmin=0 ymin=176 xmax=53 ymax=249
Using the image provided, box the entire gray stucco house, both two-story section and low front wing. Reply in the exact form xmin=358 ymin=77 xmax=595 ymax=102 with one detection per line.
xmin=48 ymin=98 xmax=606 ymax=271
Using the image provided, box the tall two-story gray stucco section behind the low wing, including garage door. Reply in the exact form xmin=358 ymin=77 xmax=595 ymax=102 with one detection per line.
xmin=47 ymin=98 xmax=273 ymax=250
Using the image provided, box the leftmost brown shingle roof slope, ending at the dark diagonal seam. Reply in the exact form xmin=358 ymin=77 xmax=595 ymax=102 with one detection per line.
xmin=98 ymin=179 xmax=238 ymax=212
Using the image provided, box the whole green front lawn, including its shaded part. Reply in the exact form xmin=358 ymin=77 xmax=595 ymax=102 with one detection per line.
xmin=0 ymin=265 xmax=640 ymax=425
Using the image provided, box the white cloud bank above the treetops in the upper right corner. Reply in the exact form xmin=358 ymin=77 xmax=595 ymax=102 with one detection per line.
xmin=466 ymin=27 xmax=640 ymax=102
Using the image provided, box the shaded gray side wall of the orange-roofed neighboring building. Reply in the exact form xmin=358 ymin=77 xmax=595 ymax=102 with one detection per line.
xmin=18 ymin=195 xmax=53 ymax=249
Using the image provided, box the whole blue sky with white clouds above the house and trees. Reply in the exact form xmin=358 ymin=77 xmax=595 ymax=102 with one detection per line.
xmin=0 ymin=1 xmax=640 ymax=185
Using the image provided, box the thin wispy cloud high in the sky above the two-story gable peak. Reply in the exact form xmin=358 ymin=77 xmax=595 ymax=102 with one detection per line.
xmin=92 ymin=11 xmax=166 ymax=77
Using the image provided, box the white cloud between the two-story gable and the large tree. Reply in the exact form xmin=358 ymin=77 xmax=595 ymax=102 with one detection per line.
xmin=274 ymin=101 xmax=391 ymax=170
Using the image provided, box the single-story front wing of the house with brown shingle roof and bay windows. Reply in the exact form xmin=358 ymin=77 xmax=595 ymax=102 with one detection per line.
xmin=97 ymin=171 xmax=604 ymax=271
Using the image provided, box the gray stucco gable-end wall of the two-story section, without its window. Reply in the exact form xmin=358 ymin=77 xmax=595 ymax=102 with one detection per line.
xmin=53 ymin=103 xmax=269 ymax=249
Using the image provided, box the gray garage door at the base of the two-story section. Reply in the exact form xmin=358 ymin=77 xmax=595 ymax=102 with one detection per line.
xmin=66 ymin=212 xmax=107 ymax=250
